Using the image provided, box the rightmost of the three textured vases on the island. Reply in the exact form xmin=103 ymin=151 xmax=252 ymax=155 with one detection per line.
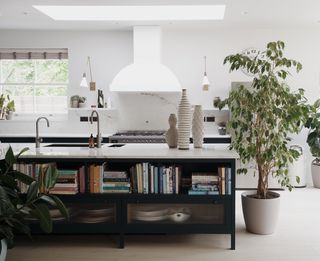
xmin=192 ymin=105 xmax=204 ymax=148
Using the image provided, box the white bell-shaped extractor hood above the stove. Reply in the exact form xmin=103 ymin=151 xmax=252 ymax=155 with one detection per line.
xmin=110 ymin=26 xmax=181 ymax=92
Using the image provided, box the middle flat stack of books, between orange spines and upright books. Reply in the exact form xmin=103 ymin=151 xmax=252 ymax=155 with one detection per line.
xmin=101 ymin=171 xmax=130 ymax=193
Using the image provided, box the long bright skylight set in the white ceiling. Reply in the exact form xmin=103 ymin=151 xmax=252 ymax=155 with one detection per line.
xmin=33 ymin=5 xmax=225 ymax=21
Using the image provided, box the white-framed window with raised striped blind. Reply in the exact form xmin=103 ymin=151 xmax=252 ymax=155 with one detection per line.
xmin=0 ymin=49 xmax=68 ymax=114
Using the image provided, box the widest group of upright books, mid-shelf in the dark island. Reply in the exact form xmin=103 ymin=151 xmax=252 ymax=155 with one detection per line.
xmin=130 ymin=162 xmax=181 ymax=194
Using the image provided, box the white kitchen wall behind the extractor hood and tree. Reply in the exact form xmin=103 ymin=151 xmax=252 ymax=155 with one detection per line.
xmin=0 ymin=28 xmax=320 ymax=183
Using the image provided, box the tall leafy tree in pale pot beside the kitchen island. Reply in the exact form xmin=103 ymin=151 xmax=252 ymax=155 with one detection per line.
xmin=219 ymin=41 xmax=309 ymax=234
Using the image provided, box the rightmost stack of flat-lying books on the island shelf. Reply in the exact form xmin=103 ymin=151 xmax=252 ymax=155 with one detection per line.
xmin=188 ymin=172 xmax=219 ymax=195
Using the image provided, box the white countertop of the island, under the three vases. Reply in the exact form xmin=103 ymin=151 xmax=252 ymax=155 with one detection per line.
xmin=2 ymin=143 xmax=238 ymax=159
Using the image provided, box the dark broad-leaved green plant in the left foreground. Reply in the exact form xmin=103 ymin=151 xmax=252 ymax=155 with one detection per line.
xmin=0 ymin=147 xmax=69 ymax=247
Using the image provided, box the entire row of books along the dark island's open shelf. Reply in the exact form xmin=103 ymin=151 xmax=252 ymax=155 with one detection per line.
xmin=15 ymin=162 xmax=232 ymax=195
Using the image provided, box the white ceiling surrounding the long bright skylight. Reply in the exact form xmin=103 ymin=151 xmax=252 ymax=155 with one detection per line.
xmin=0 ymin=0 xmax=320 ymax=30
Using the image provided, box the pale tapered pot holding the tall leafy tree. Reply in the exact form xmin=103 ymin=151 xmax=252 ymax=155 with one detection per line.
xmin=241 ymin=191 xmax=280 ymax=235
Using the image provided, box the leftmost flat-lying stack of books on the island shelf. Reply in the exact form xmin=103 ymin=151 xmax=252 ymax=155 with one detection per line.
xmin=50 ymin=169 xmax=79 ymax=194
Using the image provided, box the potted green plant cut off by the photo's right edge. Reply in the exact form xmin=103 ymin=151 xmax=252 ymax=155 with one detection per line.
xmin=305 ymin=100 xmax=320 ymax=188
